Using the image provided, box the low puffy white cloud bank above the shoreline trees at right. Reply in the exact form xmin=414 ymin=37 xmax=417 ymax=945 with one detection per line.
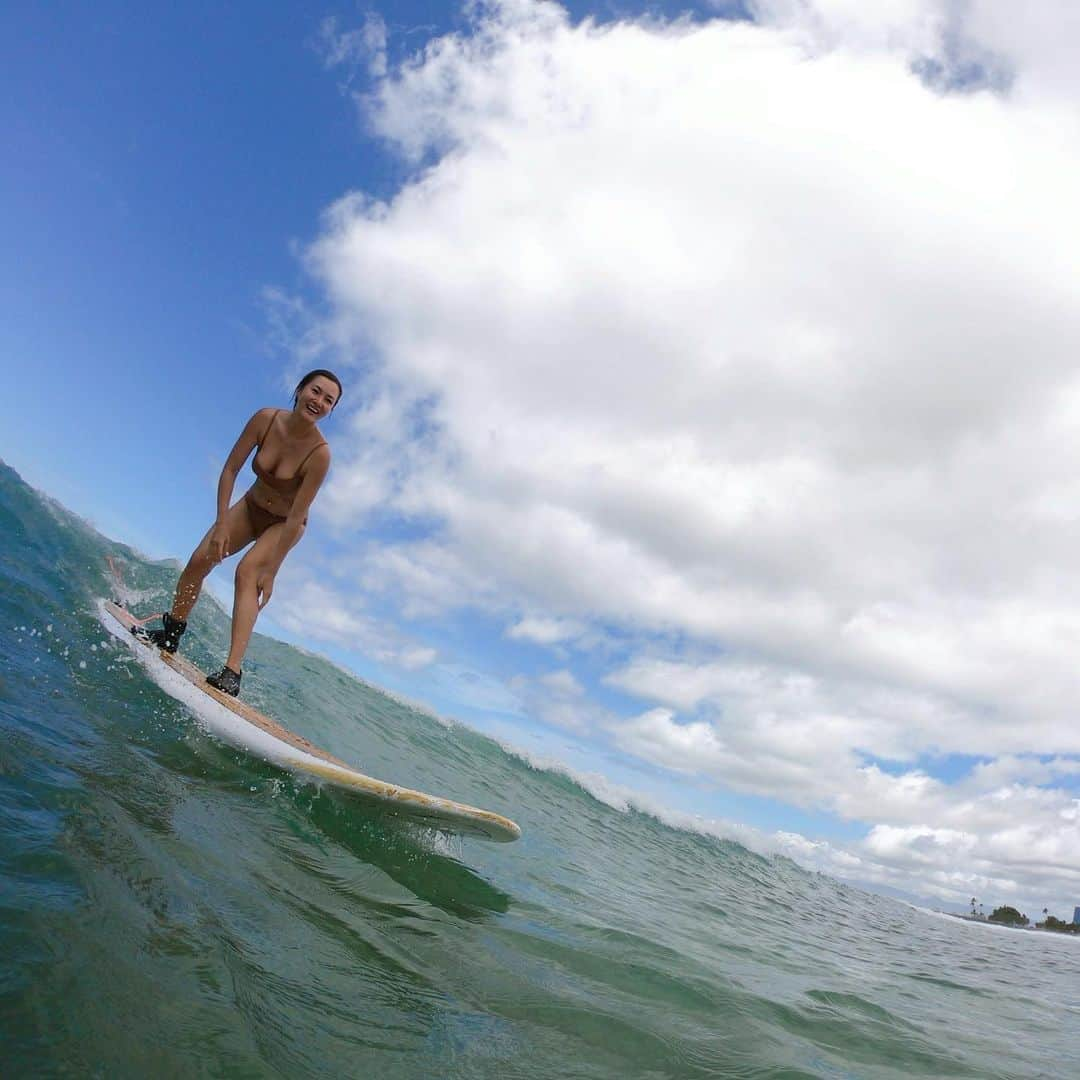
xmin=613 ymin=665 xmax=1080 ymax=910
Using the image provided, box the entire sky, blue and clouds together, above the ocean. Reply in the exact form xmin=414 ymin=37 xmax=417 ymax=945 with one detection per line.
xmin=6 ymin=0 xmax=1080 ymax=907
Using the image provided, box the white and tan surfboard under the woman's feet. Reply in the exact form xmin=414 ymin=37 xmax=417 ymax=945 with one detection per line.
xmin=100 ymin=599 xmax=522 ymax=842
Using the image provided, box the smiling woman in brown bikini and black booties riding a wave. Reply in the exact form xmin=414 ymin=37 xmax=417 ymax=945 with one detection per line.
xmin=132 ymin=368 xmax=341 ymax=697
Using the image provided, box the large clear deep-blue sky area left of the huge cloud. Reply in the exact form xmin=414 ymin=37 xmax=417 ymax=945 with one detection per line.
xmin=2 ymin=4 xmax=369 ymax=535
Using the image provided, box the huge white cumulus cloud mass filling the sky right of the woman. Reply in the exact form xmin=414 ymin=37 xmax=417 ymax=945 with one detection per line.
xmin=309 ymin=0 xmax=1080 ymax=911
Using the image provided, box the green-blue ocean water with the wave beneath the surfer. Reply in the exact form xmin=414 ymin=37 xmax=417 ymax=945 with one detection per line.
xmin=0 ymin=465 xmax=1080 ymax=1080
